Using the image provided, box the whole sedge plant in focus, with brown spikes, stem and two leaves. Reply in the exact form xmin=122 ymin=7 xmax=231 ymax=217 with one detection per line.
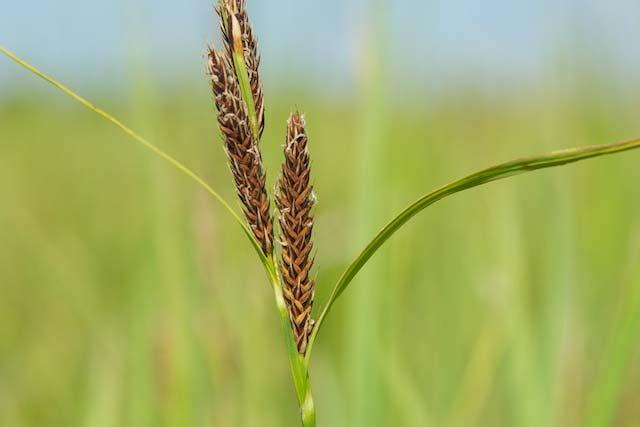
xmin=0 ymin=0 xmax=640 ymax=427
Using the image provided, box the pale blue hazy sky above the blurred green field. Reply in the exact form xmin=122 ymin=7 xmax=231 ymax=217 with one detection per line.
xmin=0 ymin=0 xmax=640 ymax=93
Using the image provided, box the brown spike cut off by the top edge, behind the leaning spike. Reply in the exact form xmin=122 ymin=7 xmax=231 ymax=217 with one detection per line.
xmin=216 ymin=0 xmax=265 ymax=139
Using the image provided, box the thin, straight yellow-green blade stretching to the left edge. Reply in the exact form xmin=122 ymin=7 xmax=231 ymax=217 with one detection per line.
xmin=0 ymin=46 xmax=268 ymax=269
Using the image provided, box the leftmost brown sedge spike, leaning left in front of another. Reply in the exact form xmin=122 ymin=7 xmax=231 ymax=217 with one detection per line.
xmin=208 ymin=49 xmax=273 ymax=255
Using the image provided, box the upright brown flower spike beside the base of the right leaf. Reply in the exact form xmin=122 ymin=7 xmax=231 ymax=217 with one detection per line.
xmin=276 ymin=113 xmax=315 ymax=354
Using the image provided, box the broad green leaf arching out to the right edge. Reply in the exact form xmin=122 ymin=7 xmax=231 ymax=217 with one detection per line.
xmin=307 ymin=138 xmax=640 ymax=359
